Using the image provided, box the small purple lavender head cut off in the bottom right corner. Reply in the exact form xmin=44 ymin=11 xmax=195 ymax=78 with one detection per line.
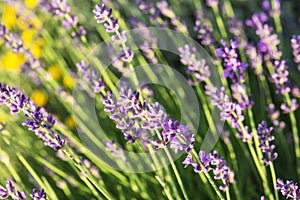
xmin=276 ymin=178 xmax=300 ymax=200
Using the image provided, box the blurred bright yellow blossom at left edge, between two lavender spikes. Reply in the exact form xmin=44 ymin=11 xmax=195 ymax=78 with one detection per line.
xmin=0 ymin=52 xmax=26 ymax=71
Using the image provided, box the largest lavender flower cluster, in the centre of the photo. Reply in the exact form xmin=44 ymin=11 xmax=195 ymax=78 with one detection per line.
xmin=103 ymin=84 xmax=195 ymax=152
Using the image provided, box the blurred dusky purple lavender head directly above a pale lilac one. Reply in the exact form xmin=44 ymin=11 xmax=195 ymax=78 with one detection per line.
xmin=194 ymin=17 xmax=216 ymax=46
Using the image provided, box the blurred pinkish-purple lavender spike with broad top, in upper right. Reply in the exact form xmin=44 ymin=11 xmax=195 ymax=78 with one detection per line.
xmin=246 ymin=13 xmax=282 ymax=61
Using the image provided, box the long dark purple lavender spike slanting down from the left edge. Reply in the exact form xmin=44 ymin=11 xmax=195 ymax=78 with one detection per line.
xmin=0 ymin=83 xmax=65 ymax=151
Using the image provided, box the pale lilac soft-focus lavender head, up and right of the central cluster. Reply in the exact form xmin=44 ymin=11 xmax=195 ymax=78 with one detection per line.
xmin=178 ymin=44 xmax=210 ymax=83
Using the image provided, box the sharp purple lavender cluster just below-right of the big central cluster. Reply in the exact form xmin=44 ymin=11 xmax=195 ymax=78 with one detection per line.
xmin=182 ymin=151 xmax=235 ymax=191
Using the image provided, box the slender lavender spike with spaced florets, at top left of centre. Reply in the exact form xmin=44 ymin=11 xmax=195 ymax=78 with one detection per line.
xmin=93 ymin=4 xmax=134 ymax=62
